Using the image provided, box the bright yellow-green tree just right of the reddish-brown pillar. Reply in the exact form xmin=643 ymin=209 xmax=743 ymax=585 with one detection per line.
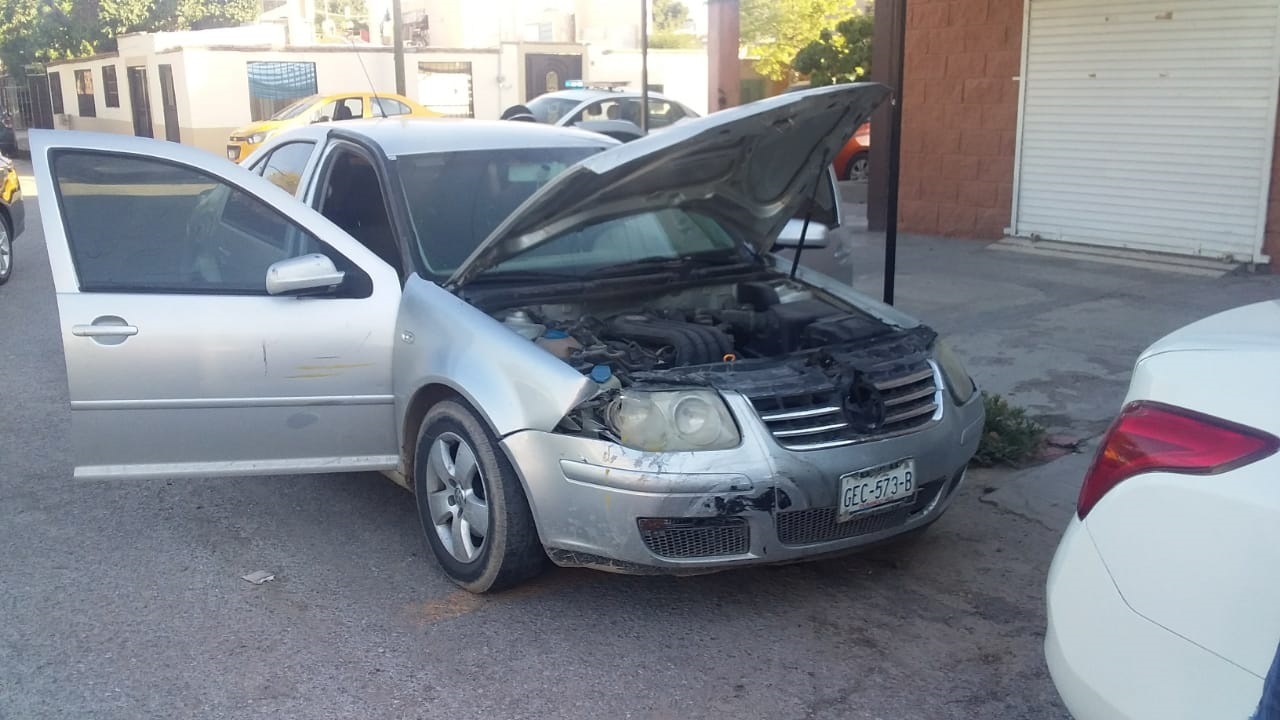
xmin=739 ymin=0 xmax=856 ymax=81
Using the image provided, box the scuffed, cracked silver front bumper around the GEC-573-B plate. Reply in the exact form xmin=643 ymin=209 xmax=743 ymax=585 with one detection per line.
xmin=503 ymin=386 xmax=983 ymax=574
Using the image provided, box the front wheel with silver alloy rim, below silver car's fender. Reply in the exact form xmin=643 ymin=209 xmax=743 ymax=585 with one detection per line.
xmin=413 ymin=401 xmax=547 ymax=593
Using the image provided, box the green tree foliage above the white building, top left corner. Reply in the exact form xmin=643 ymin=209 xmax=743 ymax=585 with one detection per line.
xmin=0 ymin=0 xmax=261 ymax=69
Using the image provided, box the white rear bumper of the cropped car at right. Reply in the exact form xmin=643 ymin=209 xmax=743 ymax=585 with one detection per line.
xmin=1044 ymin=518 xmax=1262 ymax=720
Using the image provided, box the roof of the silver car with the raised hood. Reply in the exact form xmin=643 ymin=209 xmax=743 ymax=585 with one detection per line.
xmin=318 ymin=117 xmax=618 ymax=158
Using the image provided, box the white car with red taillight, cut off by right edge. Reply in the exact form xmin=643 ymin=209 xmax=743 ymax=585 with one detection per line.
xmin=1044 ymin=301 xmax=1280 ymax=720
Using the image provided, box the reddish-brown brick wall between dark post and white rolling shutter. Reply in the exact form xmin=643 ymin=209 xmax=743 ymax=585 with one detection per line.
xmin=899 ymin=0 xmax=1018 ymax=238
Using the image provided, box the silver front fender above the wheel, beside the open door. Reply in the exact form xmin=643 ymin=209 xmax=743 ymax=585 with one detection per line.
xmin=392 ymin=274 xmax=595 ymax=437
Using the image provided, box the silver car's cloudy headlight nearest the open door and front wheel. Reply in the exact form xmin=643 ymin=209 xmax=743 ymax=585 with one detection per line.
xmin=604 ymin=389 xmax=741 ymax=452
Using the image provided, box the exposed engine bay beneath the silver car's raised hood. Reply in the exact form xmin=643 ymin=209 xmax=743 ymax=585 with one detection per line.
xmin=493 ymin=278 xmax=895 ymax=387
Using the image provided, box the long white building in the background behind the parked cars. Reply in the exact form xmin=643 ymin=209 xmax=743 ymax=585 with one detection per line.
xmin=47 ymin=18 xmax=707 ymax=155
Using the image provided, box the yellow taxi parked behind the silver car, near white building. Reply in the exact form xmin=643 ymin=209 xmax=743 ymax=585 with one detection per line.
xmin=227 ymin=92 xmax=440 ymax=163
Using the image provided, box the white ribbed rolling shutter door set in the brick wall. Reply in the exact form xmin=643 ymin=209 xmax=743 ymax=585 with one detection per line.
xmin=1014 ymin=0 xmax=1280 ymax=261
